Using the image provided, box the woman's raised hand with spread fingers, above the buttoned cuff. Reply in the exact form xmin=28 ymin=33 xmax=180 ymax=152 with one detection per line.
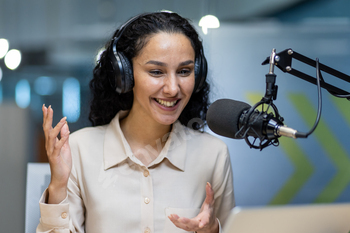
xmin=42 ymin=105 xmax=72 ymax=204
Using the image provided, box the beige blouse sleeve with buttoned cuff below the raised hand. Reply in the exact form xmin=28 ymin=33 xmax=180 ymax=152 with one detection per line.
xmin=36 ymin=161 xmax=85 ymax=233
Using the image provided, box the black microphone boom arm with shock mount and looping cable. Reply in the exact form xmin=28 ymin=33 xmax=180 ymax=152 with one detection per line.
xmin=228 ymin=49 xmax=350 ymax=150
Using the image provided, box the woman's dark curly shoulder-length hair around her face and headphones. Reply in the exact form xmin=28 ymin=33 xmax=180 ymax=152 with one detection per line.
xmin=89 ymin=12 xmax=209 ymax=130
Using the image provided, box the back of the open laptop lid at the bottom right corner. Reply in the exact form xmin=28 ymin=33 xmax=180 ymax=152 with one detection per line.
xmin=223 ymin=203 xmax=350 ymax=233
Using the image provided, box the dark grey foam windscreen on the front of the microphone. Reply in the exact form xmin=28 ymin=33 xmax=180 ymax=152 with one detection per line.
xmin=207 ymin=99 xmax=251 ymax=139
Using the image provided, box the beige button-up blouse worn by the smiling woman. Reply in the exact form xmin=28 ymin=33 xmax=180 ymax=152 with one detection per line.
xmin=37 ymin=112 xmax=234 ymax=233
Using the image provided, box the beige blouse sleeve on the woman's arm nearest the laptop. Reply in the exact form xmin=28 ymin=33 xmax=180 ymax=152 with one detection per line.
xmin=213 ymin=147 xmax=235 ymax=228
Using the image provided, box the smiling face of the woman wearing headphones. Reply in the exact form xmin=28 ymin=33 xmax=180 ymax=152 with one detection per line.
xmin=131 ymin=32 xmax=195 ymax=125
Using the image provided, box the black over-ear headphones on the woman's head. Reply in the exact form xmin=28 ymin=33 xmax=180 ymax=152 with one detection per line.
xmin=108 ymin=11 xmax=208 ymax=94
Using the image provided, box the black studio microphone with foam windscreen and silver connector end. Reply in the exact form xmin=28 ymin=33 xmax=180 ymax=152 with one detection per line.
xmin=206 ymin=99 xmax=303 ymax=143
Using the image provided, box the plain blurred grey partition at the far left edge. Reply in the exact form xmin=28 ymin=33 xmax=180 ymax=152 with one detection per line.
xmin=0 ymin=102 xmax=32 ymax=232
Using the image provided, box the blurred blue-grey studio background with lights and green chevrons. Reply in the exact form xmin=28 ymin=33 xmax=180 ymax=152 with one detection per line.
xmin=0 ymin=0 xmax=350 ymax=232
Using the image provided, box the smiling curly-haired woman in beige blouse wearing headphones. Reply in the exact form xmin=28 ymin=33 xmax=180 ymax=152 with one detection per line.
xmin=37 ymin=12 xmax=234 ymax=233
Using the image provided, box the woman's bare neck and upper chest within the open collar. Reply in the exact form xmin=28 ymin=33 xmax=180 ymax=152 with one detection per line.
xmin=120 ymin=111 xmax=171 ymax=166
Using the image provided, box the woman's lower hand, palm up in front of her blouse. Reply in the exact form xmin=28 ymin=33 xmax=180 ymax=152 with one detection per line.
xmin=168 ymin=183 xmax=219 ymax=233
